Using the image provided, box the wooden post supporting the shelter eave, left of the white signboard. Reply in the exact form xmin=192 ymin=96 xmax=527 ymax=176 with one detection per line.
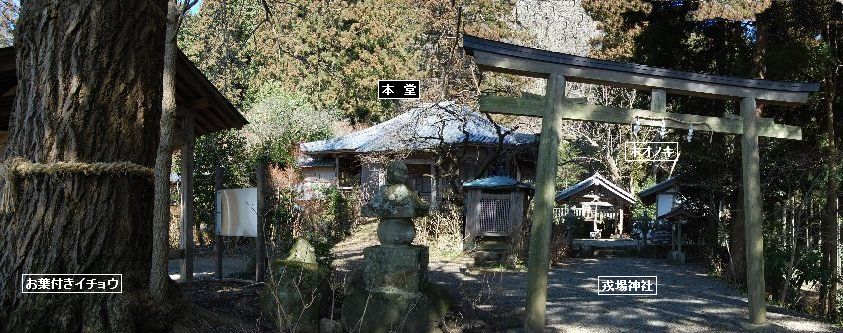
xmin=181 ymin=113 xmax=196 ymax=281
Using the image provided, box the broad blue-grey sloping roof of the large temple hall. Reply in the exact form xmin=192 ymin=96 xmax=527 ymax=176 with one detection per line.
xmin=301 ymin=102 xmax=538 ymax=154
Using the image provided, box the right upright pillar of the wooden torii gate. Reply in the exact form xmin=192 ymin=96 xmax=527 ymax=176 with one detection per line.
xmin=740 ymin=97 xmax=767 ymax=325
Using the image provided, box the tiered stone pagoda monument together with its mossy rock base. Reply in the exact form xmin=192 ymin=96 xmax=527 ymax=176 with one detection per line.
xmin=342 ymin=162 xmax=449 ymax=332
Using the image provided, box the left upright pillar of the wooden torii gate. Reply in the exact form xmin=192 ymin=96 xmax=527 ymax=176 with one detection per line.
xmin=524 ymin=74 xmax=565 ymax=332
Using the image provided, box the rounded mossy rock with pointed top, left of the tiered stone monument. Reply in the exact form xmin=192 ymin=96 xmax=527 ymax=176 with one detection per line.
xmin=260 ymin=260 xmax=331 ymax=332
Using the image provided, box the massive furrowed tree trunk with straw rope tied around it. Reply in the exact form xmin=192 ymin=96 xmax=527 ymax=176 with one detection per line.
xmin=0 ymin=0 xmax=174 ymax=332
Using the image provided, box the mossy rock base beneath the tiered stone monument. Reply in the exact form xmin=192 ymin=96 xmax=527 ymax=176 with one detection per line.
xmin=342 ymin=279 xmax=451 ymax=333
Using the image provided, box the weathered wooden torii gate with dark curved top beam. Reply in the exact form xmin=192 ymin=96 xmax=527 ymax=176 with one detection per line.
xmin=463 ymin=35 xmax=819 ymax=331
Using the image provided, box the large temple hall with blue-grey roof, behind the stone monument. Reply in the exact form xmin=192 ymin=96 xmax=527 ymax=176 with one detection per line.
xmin=299 ymin=102 xmax=538 ymax=205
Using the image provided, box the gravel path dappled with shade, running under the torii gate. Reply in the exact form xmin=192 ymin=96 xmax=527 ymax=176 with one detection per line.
xmin=334 ymin=227 xmax=843 ymax=333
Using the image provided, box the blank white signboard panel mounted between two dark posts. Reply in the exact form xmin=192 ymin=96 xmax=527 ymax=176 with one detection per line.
xmin=216 ymin=187 xmax=258 ymax=237
